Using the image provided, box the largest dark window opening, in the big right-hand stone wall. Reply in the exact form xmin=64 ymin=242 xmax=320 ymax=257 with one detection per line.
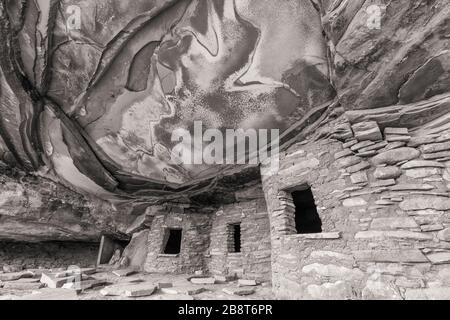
xmin=292 ymin=188 xmax=322 ymax=234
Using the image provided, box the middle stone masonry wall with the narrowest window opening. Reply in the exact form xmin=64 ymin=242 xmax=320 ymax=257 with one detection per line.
xmin=208 ymin=195 xmax=271 ymax=280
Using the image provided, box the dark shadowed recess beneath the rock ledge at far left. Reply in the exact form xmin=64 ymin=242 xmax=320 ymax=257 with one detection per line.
xmin=0 ymin=242 xmax=99 ymax=271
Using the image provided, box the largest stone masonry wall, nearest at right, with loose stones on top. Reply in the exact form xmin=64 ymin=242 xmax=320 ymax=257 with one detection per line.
xmin=263 ymin=121 xmax=450 ymax=299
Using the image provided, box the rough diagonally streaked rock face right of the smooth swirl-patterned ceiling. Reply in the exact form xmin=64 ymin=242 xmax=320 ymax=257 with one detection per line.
xmin=322 ymin=0 xmax=450 ymax=110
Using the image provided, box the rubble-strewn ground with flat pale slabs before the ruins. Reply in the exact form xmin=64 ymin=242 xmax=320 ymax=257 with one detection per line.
xmin=0 ymin=267 xmax=273 ymax=300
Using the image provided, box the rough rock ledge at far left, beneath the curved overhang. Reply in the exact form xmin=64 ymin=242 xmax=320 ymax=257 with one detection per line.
xmin=0 ymin=168 xmax=130 ymax=242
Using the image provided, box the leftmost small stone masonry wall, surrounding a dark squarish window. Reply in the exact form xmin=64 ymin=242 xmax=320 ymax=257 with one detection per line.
xmin=144 ymin=213 xmax=211 ymax=273
